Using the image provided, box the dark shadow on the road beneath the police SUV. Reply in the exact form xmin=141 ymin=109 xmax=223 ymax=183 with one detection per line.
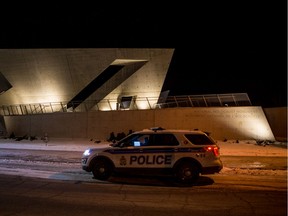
xmin=108 ymin=174 xmax=214 ymax=187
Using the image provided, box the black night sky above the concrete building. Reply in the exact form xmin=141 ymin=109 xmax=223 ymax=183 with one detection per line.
xmin=0 ymin=0 xmax=287 ymax=107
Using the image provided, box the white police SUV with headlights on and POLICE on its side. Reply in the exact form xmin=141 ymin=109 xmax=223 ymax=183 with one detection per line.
xmin=82 ymin=128 xmax=223 ymax=184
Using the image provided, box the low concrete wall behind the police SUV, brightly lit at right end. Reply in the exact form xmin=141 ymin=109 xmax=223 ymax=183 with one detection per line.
xmin=4 ymin=107 xmax=275 ymax=140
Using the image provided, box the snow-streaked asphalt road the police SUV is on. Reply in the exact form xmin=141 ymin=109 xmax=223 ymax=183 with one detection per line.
xmin=0 ymin=149 xmax=287 ymax=216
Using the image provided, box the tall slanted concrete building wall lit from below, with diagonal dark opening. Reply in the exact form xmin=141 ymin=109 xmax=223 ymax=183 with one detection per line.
xmin=0 ymin=48 xmax=174 ymax=109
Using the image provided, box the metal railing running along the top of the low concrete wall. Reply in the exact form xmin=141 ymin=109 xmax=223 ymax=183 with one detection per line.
xmin=0 ymin=93 xmax=252 ymax=116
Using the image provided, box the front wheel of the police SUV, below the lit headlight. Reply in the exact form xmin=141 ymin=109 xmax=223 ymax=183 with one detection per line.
xmin=92 ymin=158 xmax=113 ymax=181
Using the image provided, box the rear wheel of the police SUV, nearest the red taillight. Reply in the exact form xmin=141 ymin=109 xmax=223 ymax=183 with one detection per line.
xmin=174 ymin=161 xmax=200 ymax=185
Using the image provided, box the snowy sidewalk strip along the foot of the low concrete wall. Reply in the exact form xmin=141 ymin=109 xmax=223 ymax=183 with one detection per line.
xmin=0 ymin=138 xmax=287 ymax=157
